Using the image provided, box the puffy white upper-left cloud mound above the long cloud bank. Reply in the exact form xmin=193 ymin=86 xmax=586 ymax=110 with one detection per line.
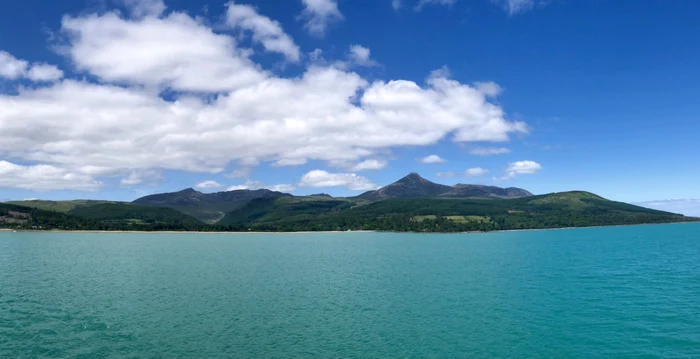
xmin=61 ymin=13 xmax=266 ymax=92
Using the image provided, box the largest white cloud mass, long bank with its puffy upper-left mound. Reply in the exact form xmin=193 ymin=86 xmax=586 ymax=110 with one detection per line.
xmin=0 ymin=4 xmax=527 ymax=193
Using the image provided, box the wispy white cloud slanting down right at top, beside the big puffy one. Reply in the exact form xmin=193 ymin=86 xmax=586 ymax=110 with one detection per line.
xmin=226 ymin=1 xmax=301 ymax=62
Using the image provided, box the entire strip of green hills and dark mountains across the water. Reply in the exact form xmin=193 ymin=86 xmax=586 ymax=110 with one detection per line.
xmin=0 ymin=173 xmax=700 ymax=232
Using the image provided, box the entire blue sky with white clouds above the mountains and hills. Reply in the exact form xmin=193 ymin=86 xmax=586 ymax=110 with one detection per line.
xmin=0 ymin=0 xmax=700 ymax=215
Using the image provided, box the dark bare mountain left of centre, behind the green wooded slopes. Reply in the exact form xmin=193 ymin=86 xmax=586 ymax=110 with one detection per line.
xmin=132 ymin=188 xmax=291 ymax=223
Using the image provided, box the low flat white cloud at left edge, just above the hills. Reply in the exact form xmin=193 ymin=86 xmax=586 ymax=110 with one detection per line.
xmin=0 ymin=161 xmax=102 ymax=191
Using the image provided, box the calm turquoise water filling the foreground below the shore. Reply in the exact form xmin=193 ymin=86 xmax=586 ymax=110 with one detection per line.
xmin=0 ymin=224 xmax=700 ymax=358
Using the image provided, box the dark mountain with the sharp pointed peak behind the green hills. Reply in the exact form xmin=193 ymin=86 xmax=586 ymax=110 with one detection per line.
xmin=357 ymin=173 xmax=532 ymax=201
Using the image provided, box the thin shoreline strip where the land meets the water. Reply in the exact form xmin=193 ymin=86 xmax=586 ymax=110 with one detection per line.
xmin=0 ymin=222 xmax=700 ymax=234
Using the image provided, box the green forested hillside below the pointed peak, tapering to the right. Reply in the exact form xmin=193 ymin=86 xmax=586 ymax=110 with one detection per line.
xmin=221 ymin=192 xmax=698 ymax=232
